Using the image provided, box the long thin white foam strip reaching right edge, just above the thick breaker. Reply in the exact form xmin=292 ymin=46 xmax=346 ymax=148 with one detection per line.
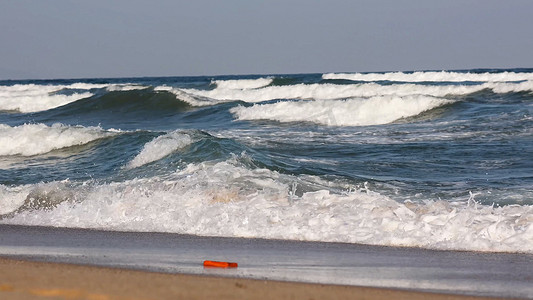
xmin=181 ymin=81 xmax=533 ymax=105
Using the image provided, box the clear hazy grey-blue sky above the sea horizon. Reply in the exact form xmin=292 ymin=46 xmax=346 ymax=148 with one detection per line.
xmin=0 ymin=0 xmax=533 ymax=80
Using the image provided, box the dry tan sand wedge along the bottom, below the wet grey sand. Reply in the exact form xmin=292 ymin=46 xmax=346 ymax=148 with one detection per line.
xmin=0 ymin=257 xmax=501 ymax=300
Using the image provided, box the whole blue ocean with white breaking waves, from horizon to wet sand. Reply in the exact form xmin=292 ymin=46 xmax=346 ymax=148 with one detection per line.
xmin=0 ymin=69 xmax=533 ymax=253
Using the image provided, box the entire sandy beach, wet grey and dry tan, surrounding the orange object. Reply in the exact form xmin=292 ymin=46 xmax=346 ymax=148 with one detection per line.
xmin=0 ymin=225 xmax=533 ymax=299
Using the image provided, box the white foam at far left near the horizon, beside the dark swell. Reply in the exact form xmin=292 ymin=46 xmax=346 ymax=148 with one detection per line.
xmin=0 ymin=84 xmax=93 ymax=113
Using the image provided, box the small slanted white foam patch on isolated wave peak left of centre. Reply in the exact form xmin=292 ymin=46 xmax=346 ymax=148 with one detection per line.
xmin=126 ymin=131 xmax=193 ymax=169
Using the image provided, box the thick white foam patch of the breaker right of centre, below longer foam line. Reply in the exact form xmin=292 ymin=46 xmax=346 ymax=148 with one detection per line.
xmin=230 ymin=96 xmax=452 ymax=126
